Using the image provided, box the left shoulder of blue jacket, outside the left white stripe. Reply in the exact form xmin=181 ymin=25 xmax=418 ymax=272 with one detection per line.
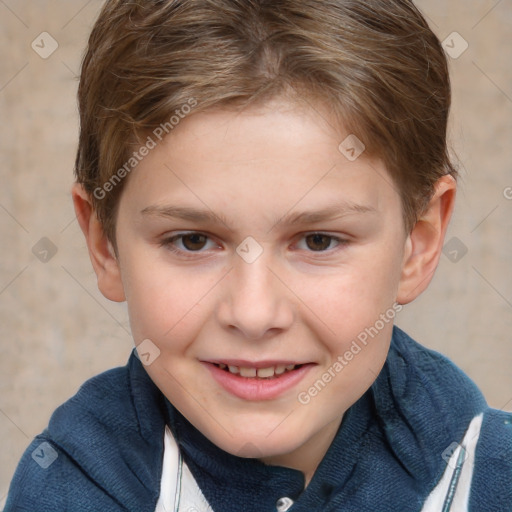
xmin=5 ymin=354 xmax=165 ymax=512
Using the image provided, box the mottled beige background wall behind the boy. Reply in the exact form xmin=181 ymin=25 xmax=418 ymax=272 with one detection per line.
xmin=0 ymin=0 xmax=512 ymax=507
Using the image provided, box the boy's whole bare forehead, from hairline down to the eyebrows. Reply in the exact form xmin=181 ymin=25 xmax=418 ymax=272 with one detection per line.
xmin=125 ymin=100 xmax=399 ymax=223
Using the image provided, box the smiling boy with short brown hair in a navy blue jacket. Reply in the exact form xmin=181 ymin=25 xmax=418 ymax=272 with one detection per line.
xmin=6 ymin=0 xmax=512 ymax=512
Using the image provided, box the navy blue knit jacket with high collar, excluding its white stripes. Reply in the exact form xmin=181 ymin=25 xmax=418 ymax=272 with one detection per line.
xmin=5 ymin=327 xmax=512 ymax=512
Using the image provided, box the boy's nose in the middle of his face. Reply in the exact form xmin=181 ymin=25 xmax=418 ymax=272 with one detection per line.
xmin=217 ymin=255 xmax=295 ymax=340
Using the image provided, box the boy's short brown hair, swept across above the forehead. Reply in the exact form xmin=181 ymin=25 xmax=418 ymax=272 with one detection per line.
xmin=75 ymin=0 xmax=456 ymax=246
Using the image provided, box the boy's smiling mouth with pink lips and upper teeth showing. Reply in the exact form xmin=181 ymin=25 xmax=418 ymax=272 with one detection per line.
xmin=202 ymin=360 xmax=316 ymax=401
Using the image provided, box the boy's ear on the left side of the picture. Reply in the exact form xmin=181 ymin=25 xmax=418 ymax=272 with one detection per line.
xmin=71 ymin=183 xmax=125 ymax=302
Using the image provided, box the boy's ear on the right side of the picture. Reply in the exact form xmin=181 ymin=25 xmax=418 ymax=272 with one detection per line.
xmin=396 ymin=175 xmax=456 ymax=304
